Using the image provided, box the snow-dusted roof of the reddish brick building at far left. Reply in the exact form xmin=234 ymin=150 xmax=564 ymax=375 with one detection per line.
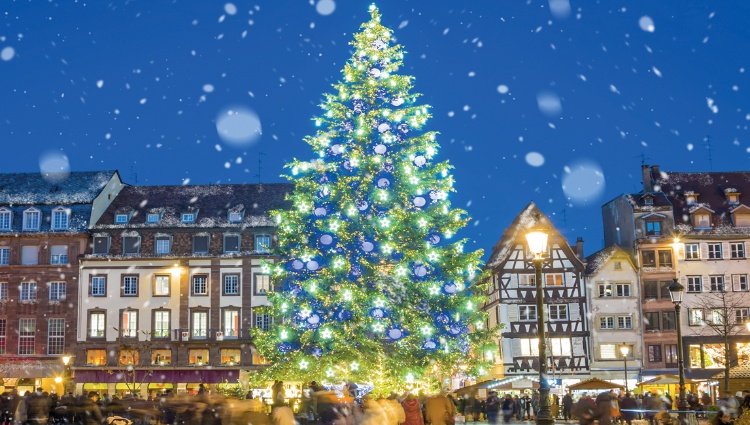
xmin=0 ymin=171 xmax=117 ymax=205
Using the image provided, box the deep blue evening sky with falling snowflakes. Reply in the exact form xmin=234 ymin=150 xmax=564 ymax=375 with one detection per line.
xmin=0 ymin=0 xmax=750 ymax=258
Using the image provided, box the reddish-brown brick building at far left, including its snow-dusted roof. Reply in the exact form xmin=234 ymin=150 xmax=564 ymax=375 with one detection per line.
xmin=0 ymin=171 xmax=123 ymax=393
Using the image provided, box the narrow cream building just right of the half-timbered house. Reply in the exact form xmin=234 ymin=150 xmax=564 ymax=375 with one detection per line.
xmin=586 ymin=245 xmax=643 ymax=388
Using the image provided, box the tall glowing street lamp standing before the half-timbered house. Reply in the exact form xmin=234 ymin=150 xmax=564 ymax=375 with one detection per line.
xmin=526 ymin=230 xmax=555 ymax=425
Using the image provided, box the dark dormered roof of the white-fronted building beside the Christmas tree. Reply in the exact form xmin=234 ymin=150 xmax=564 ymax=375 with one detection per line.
xmin=92 ymin=183 xmax=294 ymax=230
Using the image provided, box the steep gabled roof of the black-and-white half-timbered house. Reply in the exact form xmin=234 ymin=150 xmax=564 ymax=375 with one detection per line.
xmin=486 ymin=202 xmax=583 ymax=268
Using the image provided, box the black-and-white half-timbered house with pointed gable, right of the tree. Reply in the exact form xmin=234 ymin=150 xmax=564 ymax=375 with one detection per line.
xmin=483 ymin=203 xmax=591 ymax=386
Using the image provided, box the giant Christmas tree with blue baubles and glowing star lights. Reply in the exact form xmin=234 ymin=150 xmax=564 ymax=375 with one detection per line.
xmin=254 ymin=5 xmax=495 ymax=391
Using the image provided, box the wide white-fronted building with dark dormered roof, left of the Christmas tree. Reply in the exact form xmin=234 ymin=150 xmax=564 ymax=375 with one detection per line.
xmin=74 ymin=184 xmax=292 ymax=396
